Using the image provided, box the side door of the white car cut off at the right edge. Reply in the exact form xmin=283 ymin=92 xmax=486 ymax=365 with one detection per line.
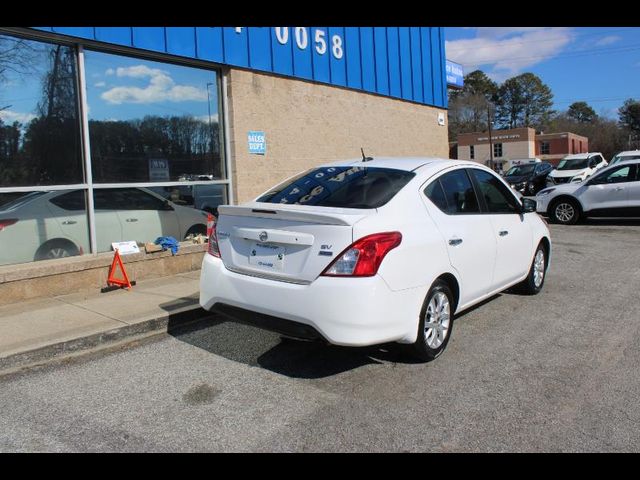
xmin=576 ymin=164 xmax=635 ymax=215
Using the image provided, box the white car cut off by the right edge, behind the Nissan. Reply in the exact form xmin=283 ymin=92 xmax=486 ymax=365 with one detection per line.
xmin=536 ymin=159 xmax=640 ymax=225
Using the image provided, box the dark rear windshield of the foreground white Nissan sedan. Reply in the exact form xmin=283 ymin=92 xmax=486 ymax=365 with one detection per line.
xmin=256 ymin=165 xmax=415 ymax=208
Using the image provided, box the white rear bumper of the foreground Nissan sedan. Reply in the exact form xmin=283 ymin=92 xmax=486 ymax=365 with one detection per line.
xmin=200 ymin=254 xmax=428 ymax=346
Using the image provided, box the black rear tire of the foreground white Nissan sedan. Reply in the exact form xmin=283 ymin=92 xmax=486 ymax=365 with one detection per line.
xmin=411 ymin=280 xmax=455 ymax=362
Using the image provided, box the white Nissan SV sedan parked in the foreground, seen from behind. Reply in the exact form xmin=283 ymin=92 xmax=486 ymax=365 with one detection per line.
xmin=200 ymin=158 xmax=551 ymax=360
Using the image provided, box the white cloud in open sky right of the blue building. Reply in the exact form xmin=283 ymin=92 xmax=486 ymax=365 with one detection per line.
xmin=446 ymin=27 xmax=573 ymax=82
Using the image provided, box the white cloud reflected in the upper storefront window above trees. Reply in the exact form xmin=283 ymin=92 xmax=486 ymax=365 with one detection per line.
xmin=100 ymin=65 xmax=207 ymax=104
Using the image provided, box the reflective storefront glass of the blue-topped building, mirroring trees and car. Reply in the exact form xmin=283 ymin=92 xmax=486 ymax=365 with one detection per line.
xmin=0 ymin=33 xmax=229 ymax=265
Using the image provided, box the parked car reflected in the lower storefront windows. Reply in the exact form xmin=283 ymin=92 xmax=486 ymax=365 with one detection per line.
xmin=0 ymin=188 xmax=207 ymax=265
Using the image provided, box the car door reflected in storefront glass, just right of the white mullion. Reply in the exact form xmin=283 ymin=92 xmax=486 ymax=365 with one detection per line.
xmin=114 ymin=188 xmax=181 ymax=242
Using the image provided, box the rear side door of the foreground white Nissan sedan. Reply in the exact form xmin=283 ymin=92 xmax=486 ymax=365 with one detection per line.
xmin=424 ymin=169 xmax=496 ymax=306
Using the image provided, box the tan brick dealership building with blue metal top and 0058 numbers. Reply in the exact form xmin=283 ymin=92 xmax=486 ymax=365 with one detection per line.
xmin=0 ymin=27 xmax=462 ymax=300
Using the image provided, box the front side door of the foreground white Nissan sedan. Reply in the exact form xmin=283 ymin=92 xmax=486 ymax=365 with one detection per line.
xmin=469 ymin=168 xmax=534 ymax=290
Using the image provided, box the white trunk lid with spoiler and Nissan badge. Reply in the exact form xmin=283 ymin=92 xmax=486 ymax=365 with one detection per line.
xmin=216 ymin=202 xmax=376 ymax=284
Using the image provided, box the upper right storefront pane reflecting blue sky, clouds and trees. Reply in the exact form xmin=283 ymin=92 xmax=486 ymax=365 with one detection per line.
xmin=85 ymin=51 xmax=224 ymax=183
